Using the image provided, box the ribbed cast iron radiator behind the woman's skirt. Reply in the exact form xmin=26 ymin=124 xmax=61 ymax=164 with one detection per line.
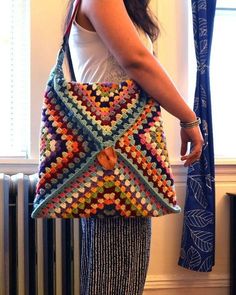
xmin=0 ymin=173 xmax=80 ymax=295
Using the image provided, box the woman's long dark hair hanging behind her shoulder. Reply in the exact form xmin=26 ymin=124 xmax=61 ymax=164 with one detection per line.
xmin=64 ymin=0 xmax=160 ymax=42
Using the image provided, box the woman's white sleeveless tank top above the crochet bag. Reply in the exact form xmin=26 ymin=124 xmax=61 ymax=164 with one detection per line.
xmin=69 ymin=3 xmax=153 ymax=83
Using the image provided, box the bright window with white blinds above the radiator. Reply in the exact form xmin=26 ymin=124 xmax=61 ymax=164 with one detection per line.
xmin=0 ymin=0 xmax=30 ymax=158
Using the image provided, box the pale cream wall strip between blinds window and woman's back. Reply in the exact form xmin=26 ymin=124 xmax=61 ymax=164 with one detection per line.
xmin=30 ymin=0 xmax=67 ymax=159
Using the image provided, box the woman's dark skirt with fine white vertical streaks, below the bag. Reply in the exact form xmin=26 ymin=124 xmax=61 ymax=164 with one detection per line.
xmin=80 ymin=217 xmax=151 ymax=295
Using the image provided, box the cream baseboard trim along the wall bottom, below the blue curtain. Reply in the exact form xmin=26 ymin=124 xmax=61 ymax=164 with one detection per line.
xmin=145 ymin=273 xmax=230 ymax=290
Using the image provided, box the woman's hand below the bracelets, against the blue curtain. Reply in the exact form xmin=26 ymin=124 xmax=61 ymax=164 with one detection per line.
xmin=180 ymin=126 xmax=204 ymax=167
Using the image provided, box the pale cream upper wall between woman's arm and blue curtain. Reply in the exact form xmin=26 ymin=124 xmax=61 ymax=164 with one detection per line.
xmin=151 ymin=0 xmax=188 ymax=164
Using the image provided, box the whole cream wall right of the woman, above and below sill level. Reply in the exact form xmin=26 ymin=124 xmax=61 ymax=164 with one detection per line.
xmin=144 ymin=0 xmax=232 ymax=295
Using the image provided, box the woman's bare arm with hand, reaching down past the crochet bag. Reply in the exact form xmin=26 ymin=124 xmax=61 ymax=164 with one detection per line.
xmin=81 ymin=0 xmax=203 ymax=166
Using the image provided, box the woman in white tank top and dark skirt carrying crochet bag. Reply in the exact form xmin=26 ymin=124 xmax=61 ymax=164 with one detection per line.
xmin=63 ymin=0 xmax=203 ymax=295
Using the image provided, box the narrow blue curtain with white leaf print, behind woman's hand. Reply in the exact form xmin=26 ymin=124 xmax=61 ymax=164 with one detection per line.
xmin=178 ymin=0 xmax=216 ymax=272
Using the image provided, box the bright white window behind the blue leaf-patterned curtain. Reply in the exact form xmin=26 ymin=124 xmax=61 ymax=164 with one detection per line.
xmin=189 ymin=0 xmax=236 ymax=159
